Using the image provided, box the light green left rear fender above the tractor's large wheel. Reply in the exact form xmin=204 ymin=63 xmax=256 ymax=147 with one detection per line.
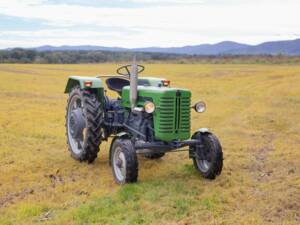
xmin=65 ymin=76 xmax=103 ymax=93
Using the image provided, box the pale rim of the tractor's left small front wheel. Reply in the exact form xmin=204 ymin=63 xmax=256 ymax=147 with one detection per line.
xmin=113 ymin=147 xmax=126 ymax=182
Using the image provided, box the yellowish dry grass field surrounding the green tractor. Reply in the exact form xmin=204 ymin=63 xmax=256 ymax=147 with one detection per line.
xmin=0 ymin=64 xmax=300 ymax=225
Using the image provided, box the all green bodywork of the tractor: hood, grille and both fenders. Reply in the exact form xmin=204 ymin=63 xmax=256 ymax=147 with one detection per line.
xmin=65 ymin=76 xmax=191 ymax=141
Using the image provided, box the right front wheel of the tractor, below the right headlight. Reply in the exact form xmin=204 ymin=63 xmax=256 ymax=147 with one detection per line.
xmin=190 ymin=132 xmax=223 ymax=179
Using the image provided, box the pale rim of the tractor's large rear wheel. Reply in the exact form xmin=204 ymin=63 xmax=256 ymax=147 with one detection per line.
xmin=67 ymin=95 xmax=86 ymax=155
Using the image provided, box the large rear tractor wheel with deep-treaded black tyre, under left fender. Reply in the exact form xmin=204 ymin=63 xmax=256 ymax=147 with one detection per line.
xmin=66 ymin=86 xmax=103 ymax=163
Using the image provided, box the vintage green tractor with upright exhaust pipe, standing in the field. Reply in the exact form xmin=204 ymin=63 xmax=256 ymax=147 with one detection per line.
xmin=65 ymin=62 xmax=223 ymax=184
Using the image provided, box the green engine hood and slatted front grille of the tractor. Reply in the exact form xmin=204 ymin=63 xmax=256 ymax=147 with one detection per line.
xmin=122 ymin=86 xmax=191 ymax=141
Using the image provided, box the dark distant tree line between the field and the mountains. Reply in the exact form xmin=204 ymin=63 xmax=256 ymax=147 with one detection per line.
xmin=0 ymin=48 xmax=300 ymax=64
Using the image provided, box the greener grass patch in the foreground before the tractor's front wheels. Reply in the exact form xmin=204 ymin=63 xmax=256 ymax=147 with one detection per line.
xmin=71 ymin=181 xmax=202 ymax=224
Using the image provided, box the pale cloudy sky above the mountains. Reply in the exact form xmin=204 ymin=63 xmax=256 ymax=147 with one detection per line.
xmin=0 ymin=0 xmax=300 ymax=49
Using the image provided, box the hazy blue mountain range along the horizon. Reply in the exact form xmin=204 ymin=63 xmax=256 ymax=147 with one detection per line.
xmin=31 ymin=39 xmax=300 ymax=55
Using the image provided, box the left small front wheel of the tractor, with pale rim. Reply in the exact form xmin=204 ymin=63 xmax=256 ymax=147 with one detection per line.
xmin=111 ymin=138 xmax=138 ymax=184
